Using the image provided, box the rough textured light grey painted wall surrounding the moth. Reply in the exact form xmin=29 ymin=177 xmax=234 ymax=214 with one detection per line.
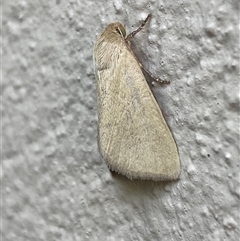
xmin=2 ymin=0 xmax=240 ymax=241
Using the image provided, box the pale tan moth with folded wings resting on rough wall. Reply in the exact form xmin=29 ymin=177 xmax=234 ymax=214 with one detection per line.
xmin=94 ymin=14 xmax=180 ymax=181
